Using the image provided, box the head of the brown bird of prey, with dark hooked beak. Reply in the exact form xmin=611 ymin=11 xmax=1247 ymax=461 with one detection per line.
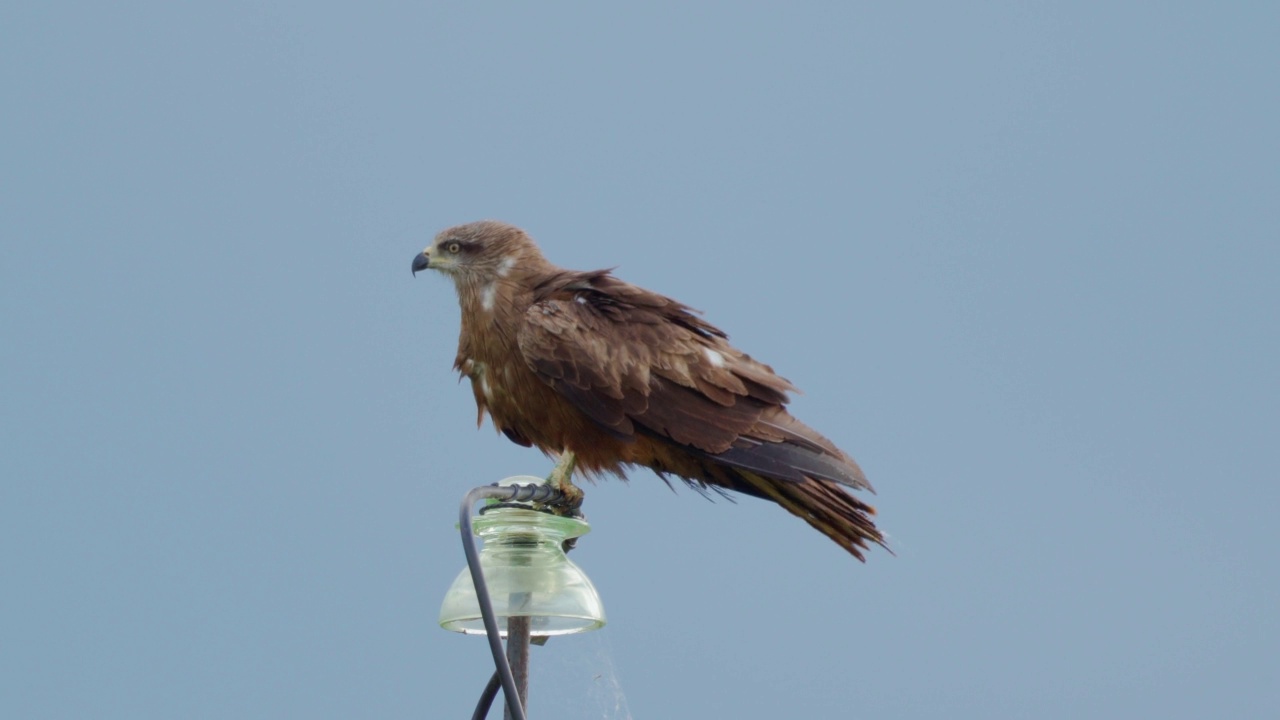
xmin=413 ymin=220 xmax=545 ymax=286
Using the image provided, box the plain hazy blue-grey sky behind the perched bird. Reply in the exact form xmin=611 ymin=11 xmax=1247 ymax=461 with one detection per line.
xmin=0 ymin=1 xmax=1280 ymax=719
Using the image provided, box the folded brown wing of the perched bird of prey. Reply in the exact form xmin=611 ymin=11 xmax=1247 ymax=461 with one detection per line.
xmin=518 ymin=270 xmax=869 ymax=488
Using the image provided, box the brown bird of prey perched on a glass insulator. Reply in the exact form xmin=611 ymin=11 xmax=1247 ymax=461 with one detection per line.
xmin=413 ymin=220 xmax=884 ymax=560
